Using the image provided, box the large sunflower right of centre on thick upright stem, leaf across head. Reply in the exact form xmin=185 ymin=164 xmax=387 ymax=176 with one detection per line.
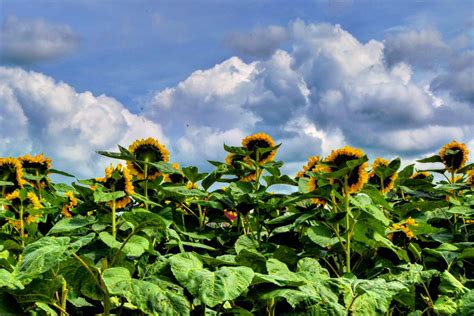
xmin=326 ymin=146 xmax=369 ymax=193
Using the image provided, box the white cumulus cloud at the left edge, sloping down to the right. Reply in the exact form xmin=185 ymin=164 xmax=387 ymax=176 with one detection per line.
xmin=0 ymin=67 xmax=167 ymax=177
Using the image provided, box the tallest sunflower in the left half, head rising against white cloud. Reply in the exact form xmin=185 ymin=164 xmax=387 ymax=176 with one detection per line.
xmin=127 ymin=137 xmax=170 ymax=180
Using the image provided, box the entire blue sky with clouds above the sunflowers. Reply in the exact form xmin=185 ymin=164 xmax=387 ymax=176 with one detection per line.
xmin=0 ymin=0 xmax=474 ymax=178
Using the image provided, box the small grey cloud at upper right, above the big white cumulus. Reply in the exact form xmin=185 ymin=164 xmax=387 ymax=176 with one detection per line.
xmin=385 ymin=28 xmax=451 ymax=69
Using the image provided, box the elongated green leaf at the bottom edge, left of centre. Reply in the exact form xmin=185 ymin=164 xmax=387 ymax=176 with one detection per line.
xmin=102 ymin=267 xmax=191 ymax=315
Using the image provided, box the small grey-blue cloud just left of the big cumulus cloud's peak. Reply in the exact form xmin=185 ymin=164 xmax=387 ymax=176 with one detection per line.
xmin=226 ymin=25 xmax=289 ymax=57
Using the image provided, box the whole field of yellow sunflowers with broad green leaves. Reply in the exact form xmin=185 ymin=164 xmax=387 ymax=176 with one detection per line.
xmin=0 ymin=133 xmax=474 ymax=315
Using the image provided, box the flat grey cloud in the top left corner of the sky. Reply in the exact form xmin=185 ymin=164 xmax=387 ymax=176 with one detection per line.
xmin=0 ymin=15 xmax=80 ymax=64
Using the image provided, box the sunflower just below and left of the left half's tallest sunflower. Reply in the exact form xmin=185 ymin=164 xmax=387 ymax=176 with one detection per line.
xmin=95 ymin=164 xmax=135 ymax=209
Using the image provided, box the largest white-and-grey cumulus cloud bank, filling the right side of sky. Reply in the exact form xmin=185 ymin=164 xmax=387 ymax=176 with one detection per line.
xmin=146 ymin=20 xmax=474 ymax=174
